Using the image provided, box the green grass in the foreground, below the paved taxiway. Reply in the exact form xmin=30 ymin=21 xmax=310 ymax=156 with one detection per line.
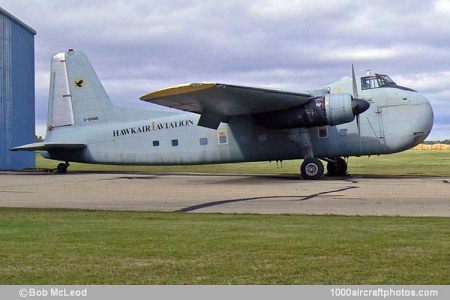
xmin=0 ymin=208 xmax=450 ymax=284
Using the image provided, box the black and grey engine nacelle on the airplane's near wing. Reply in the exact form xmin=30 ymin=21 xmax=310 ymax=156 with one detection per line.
xmin=255 ymin=94 xmax=355 ymax=129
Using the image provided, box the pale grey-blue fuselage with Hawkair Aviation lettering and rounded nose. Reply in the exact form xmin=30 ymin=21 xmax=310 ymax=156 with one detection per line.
xmin=43 ymin=80 xmax=433 ymax=165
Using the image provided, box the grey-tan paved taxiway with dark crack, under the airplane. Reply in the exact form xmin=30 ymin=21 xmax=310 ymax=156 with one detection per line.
xmin=0 ymin=172 xmax=450 ymax=217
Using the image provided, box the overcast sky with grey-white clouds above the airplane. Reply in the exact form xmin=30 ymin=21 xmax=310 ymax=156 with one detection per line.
xmin=1 ymin=0 xmax=450 ymax=139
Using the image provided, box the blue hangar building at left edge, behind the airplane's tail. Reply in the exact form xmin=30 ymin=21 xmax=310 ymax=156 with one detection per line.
xmin=0 ymin=7 xmax=36 ymax=170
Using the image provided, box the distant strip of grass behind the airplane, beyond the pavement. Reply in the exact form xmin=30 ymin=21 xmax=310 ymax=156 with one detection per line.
xmin=37 ymin=150 xmax=450 ymax=176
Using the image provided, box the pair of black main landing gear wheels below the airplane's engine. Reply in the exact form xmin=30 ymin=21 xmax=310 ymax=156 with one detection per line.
xmin=300 ymin=157 xmax=347 ymax=179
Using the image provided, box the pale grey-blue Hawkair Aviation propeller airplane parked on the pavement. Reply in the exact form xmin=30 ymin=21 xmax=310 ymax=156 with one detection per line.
xmin=11 ymin=49 xmax=433 ymax=179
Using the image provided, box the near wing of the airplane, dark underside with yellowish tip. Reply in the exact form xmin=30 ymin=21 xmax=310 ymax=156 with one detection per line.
xmin=140 ymin=83 xmax=311 ymax=129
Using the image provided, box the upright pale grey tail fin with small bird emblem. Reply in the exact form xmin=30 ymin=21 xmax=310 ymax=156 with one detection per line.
xmin=47 ymin=50 xmax=113 ymax=130
